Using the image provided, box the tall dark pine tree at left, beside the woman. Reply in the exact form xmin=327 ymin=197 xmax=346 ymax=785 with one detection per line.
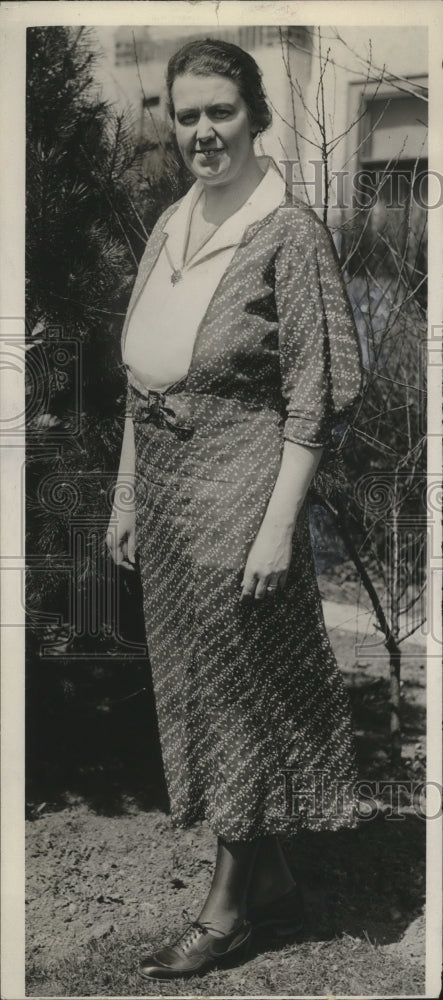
xmin=26 ymin=27 xmax=189 ymax=796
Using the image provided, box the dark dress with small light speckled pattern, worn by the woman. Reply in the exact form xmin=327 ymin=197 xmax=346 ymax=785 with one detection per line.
xmin=123 ymin=176 xmax=361 ymax=841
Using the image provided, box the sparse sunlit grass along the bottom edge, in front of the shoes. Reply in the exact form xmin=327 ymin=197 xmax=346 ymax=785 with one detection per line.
xmin=27 ymin=928 xmax=424 ymax=997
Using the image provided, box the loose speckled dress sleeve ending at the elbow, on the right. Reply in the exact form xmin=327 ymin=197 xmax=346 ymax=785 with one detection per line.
xmin=276 ymin=209 xmax=362 ymax=446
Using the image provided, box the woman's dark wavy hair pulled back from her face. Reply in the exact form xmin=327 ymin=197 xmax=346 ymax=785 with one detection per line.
xmin=166 ymin=38 xmax=272 ymax=139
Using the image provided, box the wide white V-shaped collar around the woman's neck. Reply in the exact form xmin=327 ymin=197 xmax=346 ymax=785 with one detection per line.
xmin=163 ymin=156 xmax=286 ymax=268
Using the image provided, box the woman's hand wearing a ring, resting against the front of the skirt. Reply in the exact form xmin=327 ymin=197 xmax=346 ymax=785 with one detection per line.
xmin=240 ymin=519 xmax=292 ymax=600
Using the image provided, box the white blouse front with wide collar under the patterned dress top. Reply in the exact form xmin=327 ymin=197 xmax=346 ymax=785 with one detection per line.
xmin=123 ymin=157 xmax=285 ymax=391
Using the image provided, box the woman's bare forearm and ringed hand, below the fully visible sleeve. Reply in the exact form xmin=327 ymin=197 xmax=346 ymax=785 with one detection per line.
xmin=241 ymin=440 xmax=323 ymax=600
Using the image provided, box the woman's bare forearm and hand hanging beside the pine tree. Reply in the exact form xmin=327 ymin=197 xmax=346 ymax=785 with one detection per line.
xmin=106 ymin=415 xmax=135 ymax=569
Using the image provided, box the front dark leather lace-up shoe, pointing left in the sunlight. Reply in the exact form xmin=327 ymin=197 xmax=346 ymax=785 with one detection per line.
xmin=139 ymin=920 xmax=251 ymax=979
